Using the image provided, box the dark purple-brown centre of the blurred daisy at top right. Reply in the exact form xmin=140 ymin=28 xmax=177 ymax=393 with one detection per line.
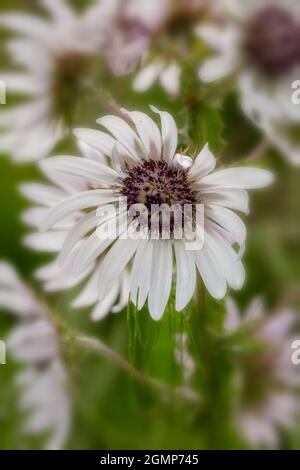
xmin=245 ymin=7 xmax=300 ymax=77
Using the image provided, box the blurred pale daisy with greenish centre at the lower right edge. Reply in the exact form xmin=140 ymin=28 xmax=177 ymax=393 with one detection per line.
xmin=225 ymin=298 xmax=300 ymax=448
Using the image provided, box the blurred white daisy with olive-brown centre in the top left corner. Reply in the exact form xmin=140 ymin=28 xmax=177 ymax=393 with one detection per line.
xmin=0 ymin=0 xmax=106 ymax=162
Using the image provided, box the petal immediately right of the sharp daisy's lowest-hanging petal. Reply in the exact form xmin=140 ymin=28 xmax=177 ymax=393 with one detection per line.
xmin=174 ymin=241 xmax=196 ymax=311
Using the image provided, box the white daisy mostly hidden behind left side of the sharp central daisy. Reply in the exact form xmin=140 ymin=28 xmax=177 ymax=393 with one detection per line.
xmin=20 ymin=143 xmax=129 ymax=321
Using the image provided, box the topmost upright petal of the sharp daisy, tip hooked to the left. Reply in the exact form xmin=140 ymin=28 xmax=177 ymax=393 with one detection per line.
xmin=151 ymin=106 xmax=178 ymax=162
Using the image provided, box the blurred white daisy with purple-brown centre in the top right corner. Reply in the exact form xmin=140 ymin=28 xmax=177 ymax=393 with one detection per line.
xmin=197 ymin=0 xmax=300 ymax=164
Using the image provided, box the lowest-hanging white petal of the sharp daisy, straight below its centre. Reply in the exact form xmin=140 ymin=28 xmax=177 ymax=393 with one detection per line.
xmin=148 ymin=240 xmax=173 ymax=320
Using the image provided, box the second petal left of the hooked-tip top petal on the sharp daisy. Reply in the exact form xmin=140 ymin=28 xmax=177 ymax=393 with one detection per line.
xmin=97 ymin=116 xmax=145 ymax=158
